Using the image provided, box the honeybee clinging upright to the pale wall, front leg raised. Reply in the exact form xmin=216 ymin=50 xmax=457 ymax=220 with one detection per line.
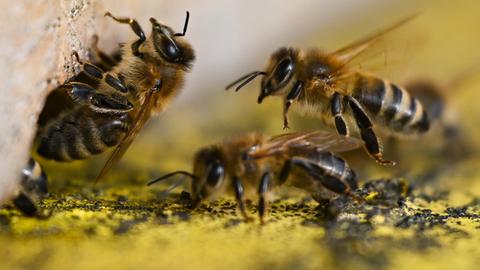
xmin=36 ymin=11 xmax=195 ymax=181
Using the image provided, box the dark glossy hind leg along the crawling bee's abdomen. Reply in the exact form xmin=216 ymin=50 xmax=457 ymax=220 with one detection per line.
xmin=292 ymin=158 xmax=350 ymax=194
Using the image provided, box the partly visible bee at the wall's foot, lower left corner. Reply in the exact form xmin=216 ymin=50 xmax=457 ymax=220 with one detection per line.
xmin=13 ymin=158 xmax=48 ymax=216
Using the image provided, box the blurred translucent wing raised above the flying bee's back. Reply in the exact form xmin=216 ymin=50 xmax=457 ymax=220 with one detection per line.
xmin=332 ymin=14 xmax=417 ymax=63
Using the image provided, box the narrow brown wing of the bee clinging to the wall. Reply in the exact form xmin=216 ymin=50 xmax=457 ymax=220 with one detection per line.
xmin=95 ymin=87 xmax=154 ymax=183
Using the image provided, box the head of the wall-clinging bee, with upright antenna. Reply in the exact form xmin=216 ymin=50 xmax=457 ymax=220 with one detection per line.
xmin=150 ymin=11 xmax=195 ymax=69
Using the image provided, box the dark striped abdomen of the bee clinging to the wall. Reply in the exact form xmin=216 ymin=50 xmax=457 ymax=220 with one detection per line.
xmin=37 ymin=107 xmax=131 ymax=161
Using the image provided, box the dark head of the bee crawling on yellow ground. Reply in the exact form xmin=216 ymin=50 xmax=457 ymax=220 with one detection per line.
xmin=192 ymin=147 xmax=225 ymax=204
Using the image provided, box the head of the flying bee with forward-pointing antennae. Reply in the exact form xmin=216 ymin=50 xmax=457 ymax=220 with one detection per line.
xmin=226 ymin=48 xmax=298 ymax=103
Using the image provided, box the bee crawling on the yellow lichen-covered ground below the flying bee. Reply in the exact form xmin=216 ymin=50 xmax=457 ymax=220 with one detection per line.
xmin=148 ymin=131 xmax=361 ymax=224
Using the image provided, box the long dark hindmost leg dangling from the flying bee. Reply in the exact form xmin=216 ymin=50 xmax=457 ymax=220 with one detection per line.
xmin=348 ymin=97 xmax=395 ymax=166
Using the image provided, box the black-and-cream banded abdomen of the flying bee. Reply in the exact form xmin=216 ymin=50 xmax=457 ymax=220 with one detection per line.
xmin=353 ymin=75 xmax=430 ymax=134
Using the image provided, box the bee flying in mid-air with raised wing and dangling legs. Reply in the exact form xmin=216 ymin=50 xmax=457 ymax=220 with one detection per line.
xmin=226 ymin=17 xmax=429 ymax=165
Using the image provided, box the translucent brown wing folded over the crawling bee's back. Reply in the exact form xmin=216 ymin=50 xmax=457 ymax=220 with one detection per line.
xmin=249 ymin=131 xmax=363 ymax=158
